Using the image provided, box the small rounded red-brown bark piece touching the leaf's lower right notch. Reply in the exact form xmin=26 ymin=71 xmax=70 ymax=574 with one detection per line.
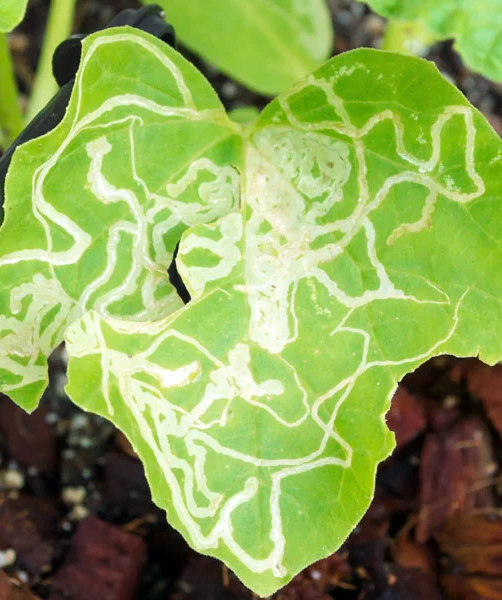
xmin=387 ymin=386 xmax=426 ymax=448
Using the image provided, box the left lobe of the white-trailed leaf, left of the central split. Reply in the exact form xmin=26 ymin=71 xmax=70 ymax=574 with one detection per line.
xmin=0 ymin=28 xmax=241 ymax=410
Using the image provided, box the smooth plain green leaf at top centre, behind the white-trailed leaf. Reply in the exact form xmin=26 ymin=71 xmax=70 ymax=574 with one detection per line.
xmin=149 ymin=0 xmax=333 ymax=96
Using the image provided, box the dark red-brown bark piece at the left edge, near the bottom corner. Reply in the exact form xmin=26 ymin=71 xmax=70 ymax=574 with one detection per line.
xmin=0 ymin=496 xmax=55 ymax=580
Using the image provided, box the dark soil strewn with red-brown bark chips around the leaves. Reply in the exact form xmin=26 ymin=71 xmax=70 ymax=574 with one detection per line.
xmin=0 ymin=0 xmax=502 ymax=600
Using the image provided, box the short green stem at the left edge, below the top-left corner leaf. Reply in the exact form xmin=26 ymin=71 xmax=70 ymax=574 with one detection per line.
xmin=0 ymin=33 xmax=24 ymax=147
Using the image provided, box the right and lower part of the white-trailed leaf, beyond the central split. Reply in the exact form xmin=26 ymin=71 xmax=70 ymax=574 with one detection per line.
xmin=63 ymin=50 xmax=502 ymax=595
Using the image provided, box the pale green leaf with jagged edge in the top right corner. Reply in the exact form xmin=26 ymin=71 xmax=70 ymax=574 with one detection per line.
xmin=364 ymin=0 xmax=502 ymax=81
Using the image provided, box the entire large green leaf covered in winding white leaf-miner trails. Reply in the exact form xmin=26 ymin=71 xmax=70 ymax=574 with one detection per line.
xmin=0 ymin=9 xmax=502 ymax=595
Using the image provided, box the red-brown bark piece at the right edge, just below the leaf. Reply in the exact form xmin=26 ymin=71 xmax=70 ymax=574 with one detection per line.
xmin=466 ymin=361 xmax=502 ymax=435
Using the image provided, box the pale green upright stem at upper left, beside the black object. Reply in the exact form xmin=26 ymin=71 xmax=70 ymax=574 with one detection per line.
xmin=27 ymin=0 xmax=76 ymax=122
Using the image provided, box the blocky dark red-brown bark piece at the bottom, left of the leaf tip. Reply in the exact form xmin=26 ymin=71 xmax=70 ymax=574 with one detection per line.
xmin=49 ymin=517 xmax=146 ymax=600
